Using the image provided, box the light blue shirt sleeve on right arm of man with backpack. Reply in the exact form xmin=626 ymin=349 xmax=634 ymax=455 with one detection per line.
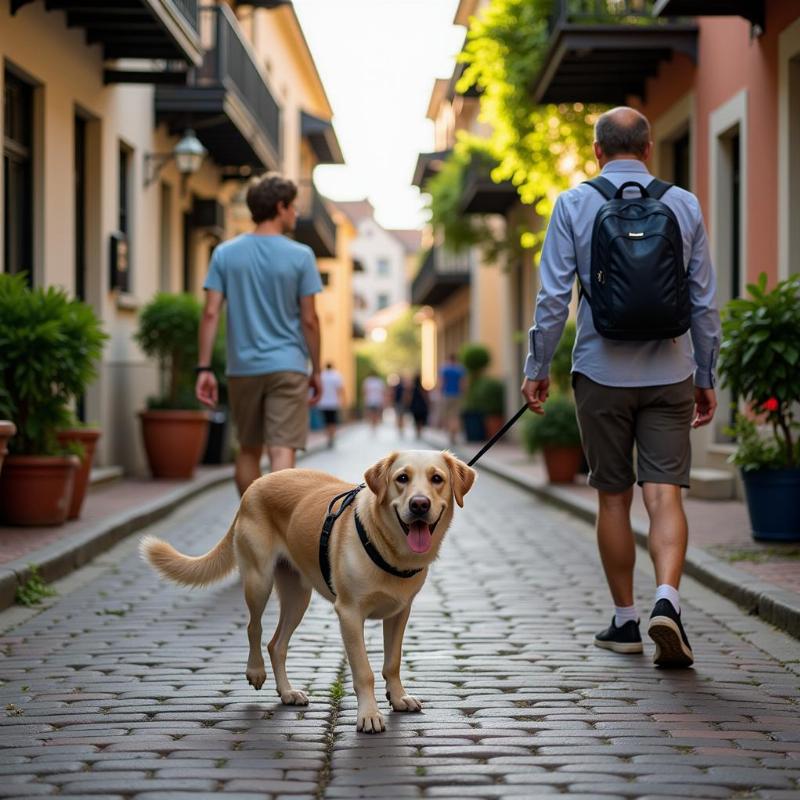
xmin=686 ymin=206 xmax=721 ymax=389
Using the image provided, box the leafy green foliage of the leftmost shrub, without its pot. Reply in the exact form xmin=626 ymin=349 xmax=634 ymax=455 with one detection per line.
xmin=0 ymin=275 xmax=108 ymax=455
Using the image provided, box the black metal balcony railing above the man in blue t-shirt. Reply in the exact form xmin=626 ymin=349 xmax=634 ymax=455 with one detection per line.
xmin=200 ymin=5 xmax=281 ymax=153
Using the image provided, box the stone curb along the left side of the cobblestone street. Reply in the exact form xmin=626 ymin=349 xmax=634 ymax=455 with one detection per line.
xmin=0 ymin=443 xmax=325 ymax=611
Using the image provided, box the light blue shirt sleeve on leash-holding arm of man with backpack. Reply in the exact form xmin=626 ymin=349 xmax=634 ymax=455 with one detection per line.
xmin=524 ymin=195 xmax=577 ymax=381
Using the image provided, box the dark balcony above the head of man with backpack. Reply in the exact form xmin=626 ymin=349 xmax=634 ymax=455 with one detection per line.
xmin=532 ymin=0 xmax=697 ymax=105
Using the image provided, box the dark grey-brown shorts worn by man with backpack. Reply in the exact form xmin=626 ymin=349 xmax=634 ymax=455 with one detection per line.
xmin=572 ymin=373 xmax=694 ymax=492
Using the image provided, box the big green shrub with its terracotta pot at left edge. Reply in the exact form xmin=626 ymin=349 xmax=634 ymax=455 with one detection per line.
xmin=0 ymin=275 xmax=107 ymax=525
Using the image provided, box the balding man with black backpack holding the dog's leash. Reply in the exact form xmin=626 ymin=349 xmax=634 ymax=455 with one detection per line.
xmin=522 ymin=107 xmax=720 ymax=667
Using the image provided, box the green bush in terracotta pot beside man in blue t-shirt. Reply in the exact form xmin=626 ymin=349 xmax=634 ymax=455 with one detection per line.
xmin=134 ymin=292 xmax=208 ymax=480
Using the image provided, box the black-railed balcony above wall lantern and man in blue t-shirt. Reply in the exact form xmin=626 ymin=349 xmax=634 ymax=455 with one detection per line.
xmin=155 ymin=5 xmax=281 ymax=170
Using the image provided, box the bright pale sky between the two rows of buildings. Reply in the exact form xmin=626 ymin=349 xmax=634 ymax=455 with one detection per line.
xmin=294 ymin=0 xmax=464 ymax=228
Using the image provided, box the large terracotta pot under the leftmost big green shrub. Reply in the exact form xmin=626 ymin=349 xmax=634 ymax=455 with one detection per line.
xmin=0 ymin=455 xmax=81 ymax=525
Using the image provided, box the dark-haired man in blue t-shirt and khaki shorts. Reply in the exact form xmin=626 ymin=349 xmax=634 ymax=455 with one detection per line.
xmin=195 ymin=174 xmax=322 ymax=494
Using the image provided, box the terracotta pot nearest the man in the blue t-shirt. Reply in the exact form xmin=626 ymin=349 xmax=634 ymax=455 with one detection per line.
xmin=139 ymin=411 xmax=208 ymax=480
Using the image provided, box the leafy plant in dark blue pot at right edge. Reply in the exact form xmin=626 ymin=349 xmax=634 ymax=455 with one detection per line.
xmin=719 ymin=273 xmax=800 ymax=541
